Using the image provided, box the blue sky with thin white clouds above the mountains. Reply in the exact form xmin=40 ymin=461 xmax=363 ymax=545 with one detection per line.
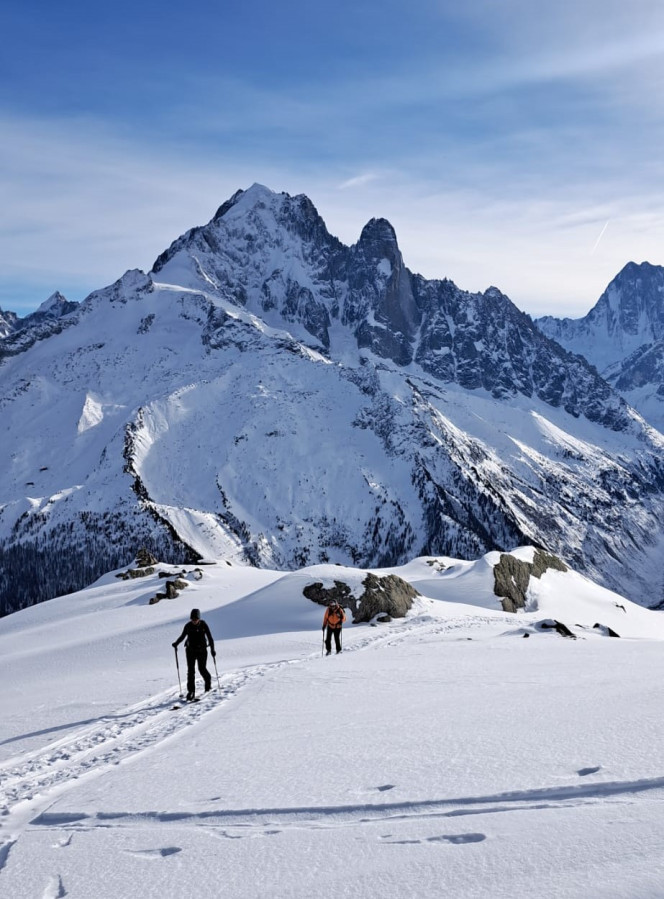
xmin=0 ymin=0 xmax=664 ymax=317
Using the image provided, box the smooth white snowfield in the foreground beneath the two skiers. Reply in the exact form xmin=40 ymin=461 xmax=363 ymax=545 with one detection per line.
xmin=0 ymin=549 xmax=664 ymax=899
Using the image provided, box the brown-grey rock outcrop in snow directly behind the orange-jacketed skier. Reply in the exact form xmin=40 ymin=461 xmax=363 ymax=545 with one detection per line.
xmin=302 ymin=574 xmax=420 ymax=624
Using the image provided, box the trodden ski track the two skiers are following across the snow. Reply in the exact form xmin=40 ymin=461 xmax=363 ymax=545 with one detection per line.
xmin=0 ymin=615 xmax=515 ymax=873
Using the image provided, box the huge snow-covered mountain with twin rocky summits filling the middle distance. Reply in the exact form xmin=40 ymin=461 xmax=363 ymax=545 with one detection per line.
xmin=0 ymin=185 xmax=664 ymax=609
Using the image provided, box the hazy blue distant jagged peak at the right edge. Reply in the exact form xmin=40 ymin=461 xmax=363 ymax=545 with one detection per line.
xmin=537 ymin=262 xmax=664 ymax=431
